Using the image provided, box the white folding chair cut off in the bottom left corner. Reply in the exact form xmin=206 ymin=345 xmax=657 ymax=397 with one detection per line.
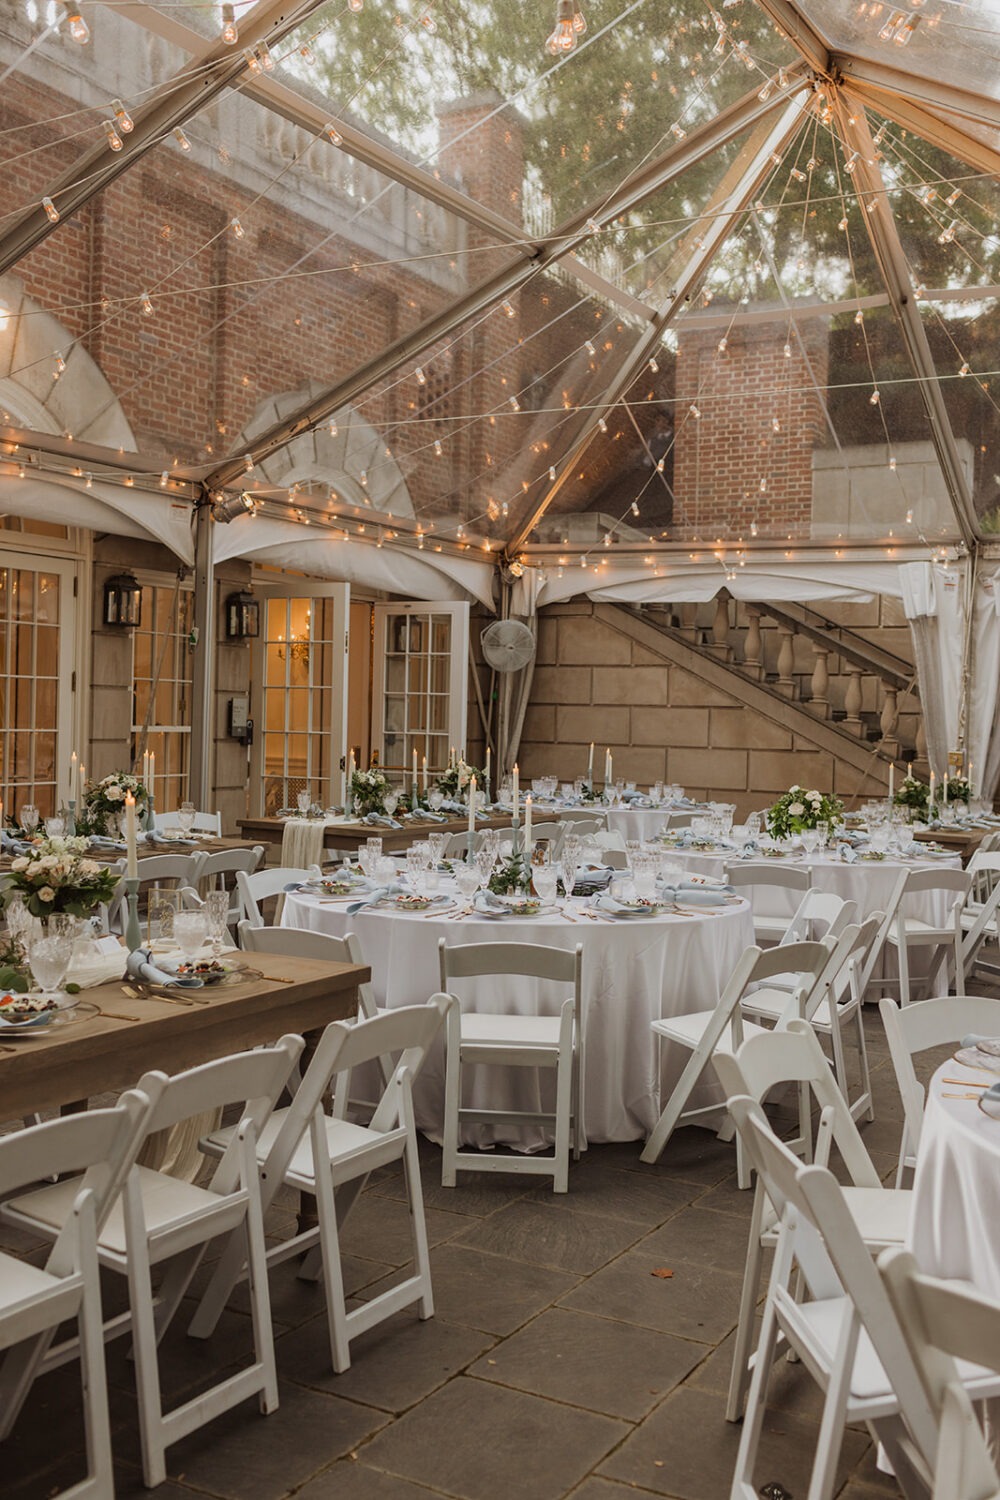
xmin=0 ymin=1091 xmax=150 ymax=1500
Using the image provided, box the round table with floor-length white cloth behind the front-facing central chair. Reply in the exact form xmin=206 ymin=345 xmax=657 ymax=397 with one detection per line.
xmin=282 ymin=893 xmax=753 ymax=1146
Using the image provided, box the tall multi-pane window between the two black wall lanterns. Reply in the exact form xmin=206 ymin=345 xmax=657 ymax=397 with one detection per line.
xmin=132 ymin=582 xmax=193 ymax=812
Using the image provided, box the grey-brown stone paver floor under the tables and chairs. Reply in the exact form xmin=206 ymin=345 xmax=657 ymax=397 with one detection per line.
xmin=0 ymin=1011 xmax=929 ymax=1500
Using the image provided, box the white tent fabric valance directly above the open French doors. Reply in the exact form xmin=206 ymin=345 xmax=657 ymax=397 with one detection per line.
xmin=214 ymin=516 xmax=495 ymax=609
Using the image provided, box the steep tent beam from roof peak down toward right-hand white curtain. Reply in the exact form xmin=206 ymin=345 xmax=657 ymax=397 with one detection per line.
xmin=837 ymin=98 xmax=979 ymax=551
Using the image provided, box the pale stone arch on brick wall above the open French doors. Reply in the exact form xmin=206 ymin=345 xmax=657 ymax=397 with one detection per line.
xmin=231 ymin=381 xmax=414 ymax=516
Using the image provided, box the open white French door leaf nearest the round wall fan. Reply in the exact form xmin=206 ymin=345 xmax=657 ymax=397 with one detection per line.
xmin=372 ymin=602 xmax=469 ymax=776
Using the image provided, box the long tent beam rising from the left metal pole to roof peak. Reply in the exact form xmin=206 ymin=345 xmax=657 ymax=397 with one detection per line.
xmin=205 ymin=76 xmax=811 ymax=488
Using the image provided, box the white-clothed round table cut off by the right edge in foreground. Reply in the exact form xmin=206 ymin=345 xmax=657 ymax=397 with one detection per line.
xmin=910 ymin=1059 xmax=1000 ymax=1299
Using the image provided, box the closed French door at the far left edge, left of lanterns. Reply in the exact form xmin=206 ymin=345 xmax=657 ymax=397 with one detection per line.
xmin=0 ymin=552 xmax=76 ymax=818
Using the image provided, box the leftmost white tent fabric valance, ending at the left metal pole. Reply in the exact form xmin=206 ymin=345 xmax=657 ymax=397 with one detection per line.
xmin=0 ymin=473 xmax=195 ymax=566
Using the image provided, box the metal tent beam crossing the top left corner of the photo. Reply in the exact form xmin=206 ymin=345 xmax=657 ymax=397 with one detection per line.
xmin=0 ymin=0 xmax=335 ymax=275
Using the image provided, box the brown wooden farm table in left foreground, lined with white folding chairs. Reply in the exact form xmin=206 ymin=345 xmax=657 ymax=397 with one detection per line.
xmin=0 ymin=953 xmax=365 ymax=1121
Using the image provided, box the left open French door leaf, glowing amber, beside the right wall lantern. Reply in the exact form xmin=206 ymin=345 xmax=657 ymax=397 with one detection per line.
xmin=250 ymin=579 xmax=351 ymax=816
